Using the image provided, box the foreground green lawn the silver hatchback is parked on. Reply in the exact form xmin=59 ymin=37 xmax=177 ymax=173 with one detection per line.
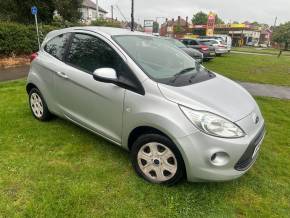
xmin=0 ymin=80 xmax=290 ymax=217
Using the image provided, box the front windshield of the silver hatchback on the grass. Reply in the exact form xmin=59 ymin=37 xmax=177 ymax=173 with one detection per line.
xmin=112 ymin=35 xmax=197 ymax=83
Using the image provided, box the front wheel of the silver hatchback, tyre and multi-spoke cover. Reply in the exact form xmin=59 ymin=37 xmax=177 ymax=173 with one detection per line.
xmin=131 ymin=134 xmax=185 ymax=185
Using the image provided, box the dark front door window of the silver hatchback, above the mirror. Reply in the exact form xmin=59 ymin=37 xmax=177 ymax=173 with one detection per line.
xmin=66 ymin=33 xmax=123 ymax=73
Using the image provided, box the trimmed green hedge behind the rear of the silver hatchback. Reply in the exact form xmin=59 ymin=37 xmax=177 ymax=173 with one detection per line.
xmin=0 ymin=22 xmax=59 ymax=56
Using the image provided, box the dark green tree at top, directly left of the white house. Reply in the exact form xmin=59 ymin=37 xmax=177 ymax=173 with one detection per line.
xmin=54 ymin=0 xmax=82 ymax=22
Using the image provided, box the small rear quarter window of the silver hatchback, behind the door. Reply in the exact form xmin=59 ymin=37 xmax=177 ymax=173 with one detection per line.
xmin=44 ymin=33 xmax=70 ymax=60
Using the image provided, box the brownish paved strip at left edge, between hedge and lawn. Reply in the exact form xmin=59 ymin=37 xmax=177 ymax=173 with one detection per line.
xmin=0 ymin=65 xmax=29 ymax=82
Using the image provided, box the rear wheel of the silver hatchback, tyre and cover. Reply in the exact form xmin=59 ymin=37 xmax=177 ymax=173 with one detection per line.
xmin=28 ymin=88 xmax=52 ymax=121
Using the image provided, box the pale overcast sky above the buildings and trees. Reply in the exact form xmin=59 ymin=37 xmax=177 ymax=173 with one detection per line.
xmin=97 ymin=0 xmax=290 ymax=25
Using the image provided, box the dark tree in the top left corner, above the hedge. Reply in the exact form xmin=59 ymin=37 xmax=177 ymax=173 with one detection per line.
xmin=0 ymin=0 xmax=55 ymax=24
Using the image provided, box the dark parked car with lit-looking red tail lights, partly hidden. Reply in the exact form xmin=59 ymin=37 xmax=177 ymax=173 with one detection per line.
xmin=180 ymin=38 xmax=215 ymax=61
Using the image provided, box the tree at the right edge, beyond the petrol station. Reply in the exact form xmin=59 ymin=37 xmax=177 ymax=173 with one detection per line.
xmin=273 ymin=21 xmax=290 ymax=50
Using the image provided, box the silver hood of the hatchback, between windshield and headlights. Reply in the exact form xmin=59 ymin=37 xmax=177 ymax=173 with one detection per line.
xmin=158 ymin=74 xmax=257 ymax=122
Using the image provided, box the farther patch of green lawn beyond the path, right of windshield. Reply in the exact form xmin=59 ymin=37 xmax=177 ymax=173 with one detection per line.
xmin=204 ymin=54 xmax=290 ymax=86
